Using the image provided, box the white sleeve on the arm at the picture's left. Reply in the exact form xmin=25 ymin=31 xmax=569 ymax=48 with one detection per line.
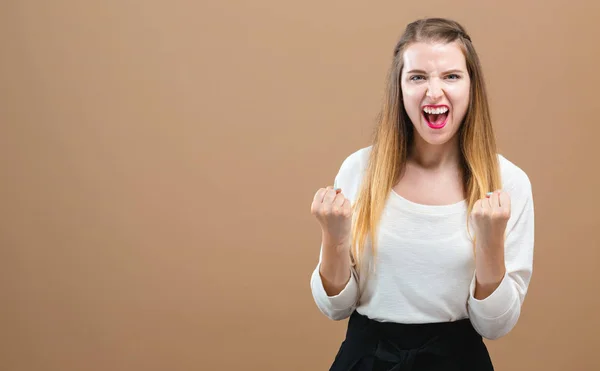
xmin=310 ymin=150 xmax=368 ymax=321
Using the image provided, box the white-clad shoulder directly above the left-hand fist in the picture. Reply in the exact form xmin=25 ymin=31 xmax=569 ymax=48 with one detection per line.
xmin=335 ymin=146 xmax=372 ymax=201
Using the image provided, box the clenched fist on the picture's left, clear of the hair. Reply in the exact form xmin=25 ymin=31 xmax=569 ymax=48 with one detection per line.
xmin=310 ymin=186 xmax=352 ymax=246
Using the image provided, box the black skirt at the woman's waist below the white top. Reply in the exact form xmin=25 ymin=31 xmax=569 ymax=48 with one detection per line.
xmin=329 ymin=311 xmax=494 ymax=371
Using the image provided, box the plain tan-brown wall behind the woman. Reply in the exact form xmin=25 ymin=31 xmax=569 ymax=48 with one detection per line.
xmin=0 ymin=0 xmax=600 ymax=371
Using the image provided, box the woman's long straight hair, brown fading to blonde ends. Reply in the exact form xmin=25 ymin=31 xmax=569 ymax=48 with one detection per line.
xmin=351 ymin=18 xmax=501 ymax=266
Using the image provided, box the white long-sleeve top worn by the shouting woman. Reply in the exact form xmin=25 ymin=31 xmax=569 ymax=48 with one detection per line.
xmin=310 ymin=146 xmax=534 ymax=339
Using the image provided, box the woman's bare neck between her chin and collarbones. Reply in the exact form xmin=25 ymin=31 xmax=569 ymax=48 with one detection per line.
xmin=408 ymin=135 xmax=461 ymax=170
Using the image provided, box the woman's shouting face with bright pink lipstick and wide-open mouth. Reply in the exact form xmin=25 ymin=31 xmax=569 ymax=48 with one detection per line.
xmin=401 ymin=42 xmax=471 ymax=145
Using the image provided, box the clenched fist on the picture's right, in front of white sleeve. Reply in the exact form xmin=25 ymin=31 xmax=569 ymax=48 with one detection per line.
xmin=471 ymin=190 xmax=510 ymax=246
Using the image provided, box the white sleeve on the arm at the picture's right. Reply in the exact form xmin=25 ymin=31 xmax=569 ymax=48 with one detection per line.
xmin=468 ymin=173 xmax=534 ymax=340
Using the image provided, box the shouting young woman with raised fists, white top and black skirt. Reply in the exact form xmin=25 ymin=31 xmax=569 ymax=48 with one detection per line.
xmin=311 ymin=18 xmax=534 ymax=371
